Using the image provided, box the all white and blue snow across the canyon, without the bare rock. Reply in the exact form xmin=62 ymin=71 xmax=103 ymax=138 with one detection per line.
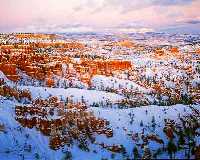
xmin=0 ymin=32 xmax=200 ymax=160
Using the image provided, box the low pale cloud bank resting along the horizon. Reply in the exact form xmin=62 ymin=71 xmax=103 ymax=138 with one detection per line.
xmin=3 ymin=23 xmax=154 ymax=33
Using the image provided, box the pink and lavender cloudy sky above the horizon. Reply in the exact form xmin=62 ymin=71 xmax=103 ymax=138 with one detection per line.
xmin=0 ymin=0 xmax=200 ymax=33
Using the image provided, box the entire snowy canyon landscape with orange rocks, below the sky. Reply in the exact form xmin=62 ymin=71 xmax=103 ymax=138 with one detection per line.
xmin=0 ymin=33 xmax=200 ymax=160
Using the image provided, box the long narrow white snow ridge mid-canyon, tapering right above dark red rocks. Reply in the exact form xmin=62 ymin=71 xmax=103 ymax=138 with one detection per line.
xmin=19 ymin=86 xmax=123 ymax=105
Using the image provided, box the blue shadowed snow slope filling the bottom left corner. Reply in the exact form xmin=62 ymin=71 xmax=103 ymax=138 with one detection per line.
xmin=0 ymin=97 xmax=61 ymax=160
